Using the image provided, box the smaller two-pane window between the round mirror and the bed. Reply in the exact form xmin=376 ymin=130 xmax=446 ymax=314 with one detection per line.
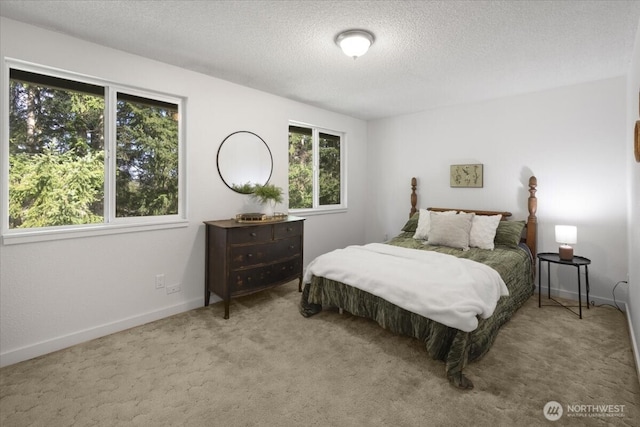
xmin=289 ymin=123 xmax=346 ymax=210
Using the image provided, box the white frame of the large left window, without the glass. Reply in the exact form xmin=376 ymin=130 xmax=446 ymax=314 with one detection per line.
xmin=0 ymin=58 xmax=188 ymax=245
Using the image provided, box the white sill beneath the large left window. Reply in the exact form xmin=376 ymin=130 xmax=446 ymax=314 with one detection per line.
xmin=2 ymin=219 xmax=189 ymax=246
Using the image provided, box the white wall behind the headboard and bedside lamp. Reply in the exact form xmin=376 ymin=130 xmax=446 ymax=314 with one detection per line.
xmin=366 ymin=76 xmax=629 ymax=303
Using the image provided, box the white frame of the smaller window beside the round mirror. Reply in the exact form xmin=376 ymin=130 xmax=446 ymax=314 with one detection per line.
xmin=287 ymin=120 xmax=347 ymax=215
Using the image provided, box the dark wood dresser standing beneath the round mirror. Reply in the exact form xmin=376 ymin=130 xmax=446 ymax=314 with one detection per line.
xmin=204 ymin=216 xmax=304 ymax=319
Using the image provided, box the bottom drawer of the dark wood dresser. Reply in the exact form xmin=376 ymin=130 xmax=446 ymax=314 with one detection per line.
xmin=230 ymin=258 xmax=302 ymax=293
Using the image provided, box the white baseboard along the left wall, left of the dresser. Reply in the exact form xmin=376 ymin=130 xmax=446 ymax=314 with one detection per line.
xmin=0 ymin=298 xmax=203 ymax=368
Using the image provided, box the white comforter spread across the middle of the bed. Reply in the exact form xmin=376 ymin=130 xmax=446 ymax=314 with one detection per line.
xmin=304 ymin=243 xmax=509 ymax=332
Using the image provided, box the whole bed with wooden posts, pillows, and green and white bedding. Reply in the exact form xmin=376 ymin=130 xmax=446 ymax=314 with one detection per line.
xmin=299 ymin=176 xmax=537 ymax=389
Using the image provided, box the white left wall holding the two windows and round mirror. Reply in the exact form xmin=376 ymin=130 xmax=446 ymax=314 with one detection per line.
xmin=0 ymin=18 xmax=367 ymax=365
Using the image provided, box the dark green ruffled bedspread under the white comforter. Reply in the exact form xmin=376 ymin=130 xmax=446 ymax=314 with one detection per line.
xmin=300 ymin=233 xmax=534 ymax=388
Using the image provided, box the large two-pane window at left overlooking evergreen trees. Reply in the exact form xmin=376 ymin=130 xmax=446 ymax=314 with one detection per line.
xmin=2 ymin=62 xmax=184 ymax=241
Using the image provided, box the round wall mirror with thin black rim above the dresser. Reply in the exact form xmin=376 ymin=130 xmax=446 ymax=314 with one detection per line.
xmin=216 ymin=130 xmax=273 ymax=194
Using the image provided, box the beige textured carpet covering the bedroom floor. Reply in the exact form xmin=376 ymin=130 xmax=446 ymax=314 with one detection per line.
xmin=0 ymin=283 xmax=640 ymax=427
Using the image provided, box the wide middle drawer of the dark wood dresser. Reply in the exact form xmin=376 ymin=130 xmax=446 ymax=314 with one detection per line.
xmin=230 ymin=236 xmax=301 ymax=270
